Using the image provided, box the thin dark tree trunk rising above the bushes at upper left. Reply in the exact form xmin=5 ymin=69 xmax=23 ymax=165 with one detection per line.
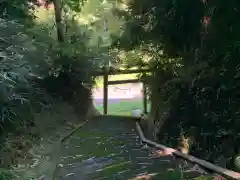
xmin=53 ymin=0 xmax=64 ymax=42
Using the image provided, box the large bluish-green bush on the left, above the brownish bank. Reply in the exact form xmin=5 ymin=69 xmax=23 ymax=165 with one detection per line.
xmin=0 ymin=16 xmax=101 ymax=132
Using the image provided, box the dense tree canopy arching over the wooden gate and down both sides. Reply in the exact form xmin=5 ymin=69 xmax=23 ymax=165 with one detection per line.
xmin=0 ymin=0 xmax=240 ymax=174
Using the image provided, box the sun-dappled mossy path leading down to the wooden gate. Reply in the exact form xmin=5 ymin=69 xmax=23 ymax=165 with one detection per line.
xmin=56 ymin=116 xmax=212 ymax=180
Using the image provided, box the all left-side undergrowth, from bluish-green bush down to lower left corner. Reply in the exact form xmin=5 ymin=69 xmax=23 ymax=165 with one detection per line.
xmin=0 ymin=15 xmax=94 ymax=168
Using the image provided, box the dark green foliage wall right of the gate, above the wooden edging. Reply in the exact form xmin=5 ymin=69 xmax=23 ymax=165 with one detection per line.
xmin=117 ymin=0 xmax=240 ymax=169
